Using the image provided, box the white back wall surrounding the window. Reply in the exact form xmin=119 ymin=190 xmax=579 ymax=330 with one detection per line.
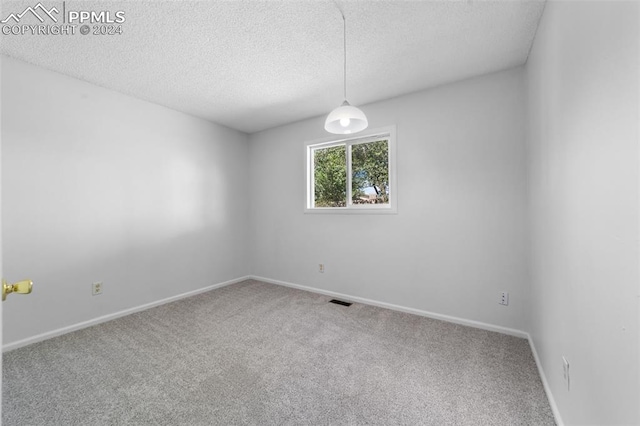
xmin=250 ymin=68 xmax=529 ymax=330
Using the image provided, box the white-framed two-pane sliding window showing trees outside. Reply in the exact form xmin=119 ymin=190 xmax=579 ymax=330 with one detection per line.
xmin=305 ymin=127 xmax=397 ymax=213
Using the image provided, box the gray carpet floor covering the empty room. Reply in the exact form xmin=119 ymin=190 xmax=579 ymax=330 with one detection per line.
xmin=2 ymin=281 xmax=554 ymax=426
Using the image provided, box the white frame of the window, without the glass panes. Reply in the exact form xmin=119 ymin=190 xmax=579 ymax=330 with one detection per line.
xmin=304 ymin=125 xmax=398 ymax=214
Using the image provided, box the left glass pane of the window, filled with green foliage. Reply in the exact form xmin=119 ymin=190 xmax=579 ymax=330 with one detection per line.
xmin=313 ymin=145 xmax=347 ymax=207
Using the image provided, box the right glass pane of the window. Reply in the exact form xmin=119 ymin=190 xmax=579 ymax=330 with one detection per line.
xmin=351 ymin=140 xmax=389 ymax=204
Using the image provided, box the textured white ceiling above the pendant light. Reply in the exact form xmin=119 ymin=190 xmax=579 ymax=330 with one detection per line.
xmin=1 ymin=0 xmax=544 ymax=133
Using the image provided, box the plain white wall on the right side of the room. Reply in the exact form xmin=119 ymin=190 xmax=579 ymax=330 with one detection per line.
xmin=527 ymin=1 xmax=640 ymax=425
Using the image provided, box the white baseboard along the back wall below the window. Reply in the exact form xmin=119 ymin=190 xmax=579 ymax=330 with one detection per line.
xmin=249 ymin=275 xmax=529 ymax=339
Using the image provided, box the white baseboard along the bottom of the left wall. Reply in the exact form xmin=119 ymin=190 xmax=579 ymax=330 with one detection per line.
xmin=2 ymin=276 xmax=251 ymax=352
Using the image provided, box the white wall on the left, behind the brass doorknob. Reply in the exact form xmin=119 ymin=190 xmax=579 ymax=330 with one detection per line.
xmin=2 ymin=57 xmax=249 ymax=344
